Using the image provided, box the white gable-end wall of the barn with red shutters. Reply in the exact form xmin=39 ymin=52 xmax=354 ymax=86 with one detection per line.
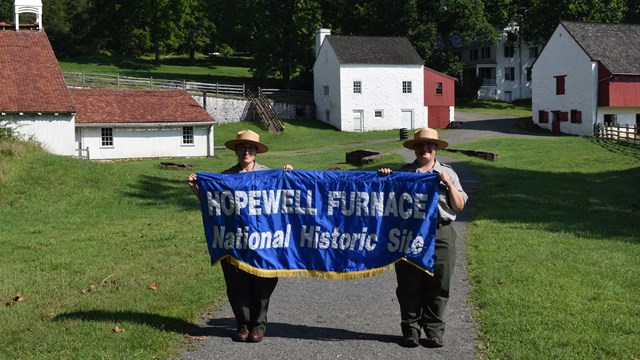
xmin=531 ymin=25 xmax=598 ymax=136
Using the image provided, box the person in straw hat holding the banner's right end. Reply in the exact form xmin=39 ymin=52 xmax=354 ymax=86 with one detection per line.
xmin=378 ymin=128 xmax=468 ymax=348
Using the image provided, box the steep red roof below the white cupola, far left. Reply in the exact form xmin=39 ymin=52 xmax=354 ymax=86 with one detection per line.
xmin=0 ymin=30 xmax=75 ymax=113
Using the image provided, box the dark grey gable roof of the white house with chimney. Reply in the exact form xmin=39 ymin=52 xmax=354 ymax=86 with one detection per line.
xmin=324 ymin=35 xmax=424 ymax=65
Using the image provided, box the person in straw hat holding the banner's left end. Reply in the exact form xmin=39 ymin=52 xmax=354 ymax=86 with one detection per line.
xmin=187 ymin=130 xmax=293 ymax=342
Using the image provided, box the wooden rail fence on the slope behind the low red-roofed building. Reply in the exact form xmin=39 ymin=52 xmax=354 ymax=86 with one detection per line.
xmin=64 ymin=72 xmax=313 ymax=102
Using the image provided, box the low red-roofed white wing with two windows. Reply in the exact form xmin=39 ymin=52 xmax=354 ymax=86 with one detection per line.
xmin=71 ymin=89 xmax=214 ymax=159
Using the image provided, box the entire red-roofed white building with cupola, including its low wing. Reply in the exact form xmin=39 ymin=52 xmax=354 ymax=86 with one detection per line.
xmin=0 ymin=0 xmax=214 ymax=159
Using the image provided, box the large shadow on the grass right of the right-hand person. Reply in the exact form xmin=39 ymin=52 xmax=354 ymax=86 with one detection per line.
xmin=461 ymin=163 xmax=640 ymax=245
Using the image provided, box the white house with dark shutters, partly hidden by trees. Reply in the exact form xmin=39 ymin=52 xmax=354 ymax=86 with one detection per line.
xmin=457 ymin=23 xmax=541 ymax=102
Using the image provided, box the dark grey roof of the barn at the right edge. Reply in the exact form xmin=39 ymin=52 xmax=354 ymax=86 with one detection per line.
xmin=560 ymin=21 xmax=640 ymax=74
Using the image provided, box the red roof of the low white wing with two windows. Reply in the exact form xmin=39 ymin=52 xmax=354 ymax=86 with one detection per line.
xmin=70 ymin=88 xmax=213 ymax=124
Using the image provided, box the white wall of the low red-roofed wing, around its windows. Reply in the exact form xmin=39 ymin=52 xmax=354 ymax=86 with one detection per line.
xmin=76 ymin=126 xmax=213 ymax=160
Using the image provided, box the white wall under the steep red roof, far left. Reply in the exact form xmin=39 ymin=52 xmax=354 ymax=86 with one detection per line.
xmin=0 ymin=113 xmax=76 ymax=156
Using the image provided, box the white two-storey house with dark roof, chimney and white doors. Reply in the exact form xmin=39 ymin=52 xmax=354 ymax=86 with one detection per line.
xmin=313 ymin=29 xmax=427 ymax=131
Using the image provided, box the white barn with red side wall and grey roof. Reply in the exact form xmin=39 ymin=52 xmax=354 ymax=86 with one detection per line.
xmin=531 ymin=21 xmax=640 ymax=136
